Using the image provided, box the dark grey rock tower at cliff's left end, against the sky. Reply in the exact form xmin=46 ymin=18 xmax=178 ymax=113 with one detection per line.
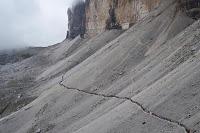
xmin=67 ymin=2 xmax=85 ymax=38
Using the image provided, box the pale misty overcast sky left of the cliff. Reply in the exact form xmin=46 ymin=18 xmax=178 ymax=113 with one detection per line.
xmin=0 ymin=0 xmax=73 ymax=49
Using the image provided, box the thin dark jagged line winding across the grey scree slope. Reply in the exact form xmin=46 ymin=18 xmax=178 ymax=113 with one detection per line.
xmin=59 ymin=76 xmax=193 ymax=133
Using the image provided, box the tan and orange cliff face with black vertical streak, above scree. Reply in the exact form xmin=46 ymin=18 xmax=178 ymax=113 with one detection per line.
xmin=86 ymin=0 xmax=160 ymax=35
